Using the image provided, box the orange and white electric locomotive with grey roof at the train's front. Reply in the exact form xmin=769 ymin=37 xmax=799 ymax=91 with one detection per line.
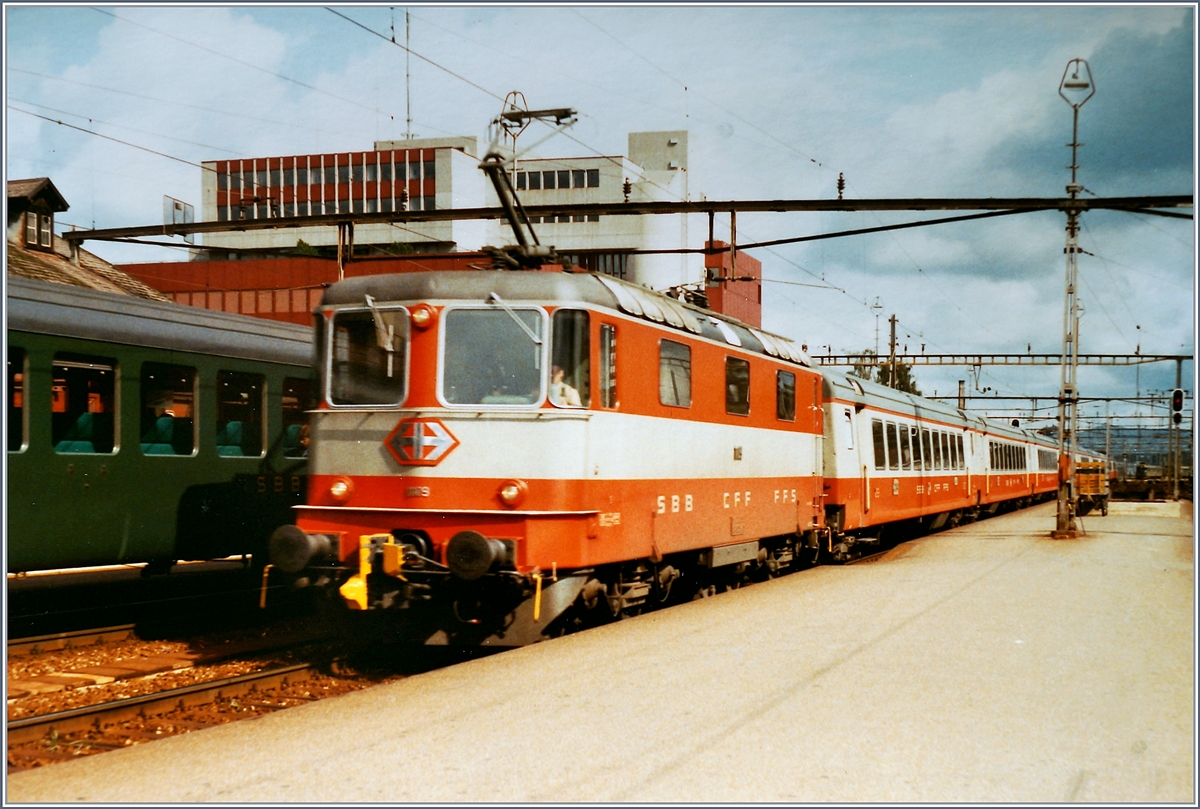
xmin=271 ymin=271 xmax=824 ymax=643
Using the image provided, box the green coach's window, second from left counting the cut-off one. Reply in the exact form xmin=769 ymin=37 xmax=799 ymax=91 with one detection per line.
xmin=50 ymin=354 xmax=116 ymax=453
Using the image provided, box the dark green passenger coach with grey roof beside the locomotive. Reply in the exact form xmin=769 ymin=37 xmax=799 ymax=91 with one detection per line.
xmin=5 ymin=276 xmax=312 ymax=574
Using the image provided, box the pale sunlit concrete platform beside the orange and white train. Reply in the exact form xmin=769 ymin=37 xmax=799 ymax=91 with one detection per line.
xmin=7 ymin=504 xmax=1196 ymax=803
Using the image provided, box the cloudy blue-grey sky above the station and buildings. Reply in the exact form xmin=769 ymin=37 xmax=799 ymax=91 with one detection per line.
xmin=5 ymin=5 xmax=1195 ymax=422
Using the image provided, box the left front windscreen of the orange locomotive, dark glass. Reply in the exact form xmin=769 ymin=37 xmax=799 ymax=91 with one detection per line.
xmin=329 ymin=306 xmax=408 ymax=405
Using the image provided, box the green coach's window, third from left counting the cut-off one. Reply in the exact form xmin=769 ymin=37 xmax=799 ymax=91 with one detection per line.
xmin=142 ymin=362 xmax=196 ymax=455
